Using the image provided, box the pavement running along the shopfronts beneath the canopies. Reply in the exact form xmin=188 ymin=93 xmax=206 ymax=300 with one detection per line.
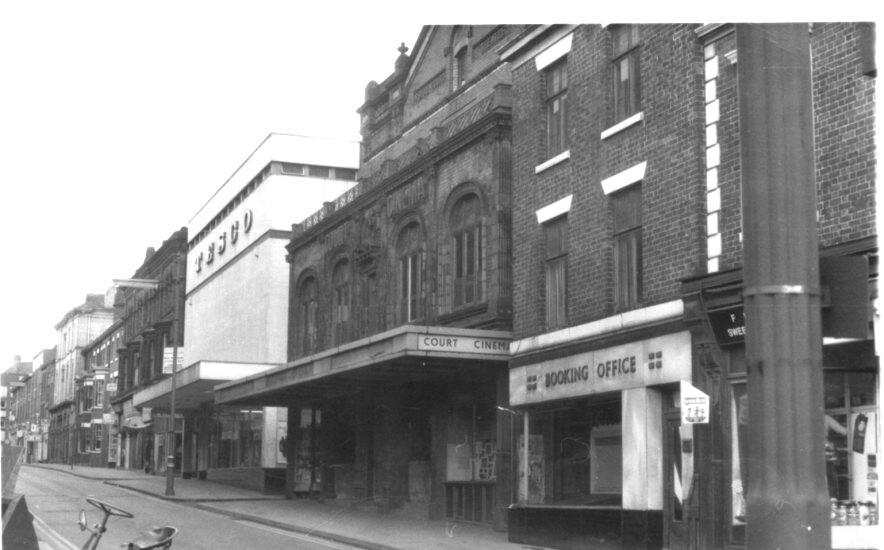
xmin=25 ymin=464 xmax=537 ymax=550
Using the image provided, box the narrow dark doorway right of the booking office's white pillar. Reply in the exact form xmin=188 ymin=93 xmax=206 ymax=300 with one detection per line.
xmin=663 ymin=402 xmax=694 ymax=550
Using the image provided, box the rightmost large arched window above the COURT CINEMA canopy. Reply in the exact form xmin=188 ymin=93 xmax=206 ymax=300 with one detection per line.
xmin=451 ymin=194 xmax=484 ymax=308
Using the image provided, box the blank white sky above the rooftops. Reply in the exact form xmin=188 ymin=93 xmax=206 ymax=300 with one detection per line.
xmin=0 ymin=0 xmax=872 ymax=370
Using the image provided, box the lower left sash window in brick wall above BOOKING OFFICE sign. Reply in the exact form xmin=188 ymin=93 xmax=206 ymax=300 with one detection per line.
xmin=543 ymin=216 xmax=568 ymax=330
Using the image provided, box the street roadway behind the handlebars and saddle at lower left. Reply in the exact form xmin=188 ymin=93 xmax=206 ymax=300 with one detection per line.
xmin=16 ymin=467 xmax=370 ymax=550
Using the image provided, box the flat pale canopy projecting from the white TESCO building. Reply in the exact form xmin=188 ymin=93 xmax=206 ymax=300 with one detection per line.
xmin=132 ymin=361 xmax=279 ymax=410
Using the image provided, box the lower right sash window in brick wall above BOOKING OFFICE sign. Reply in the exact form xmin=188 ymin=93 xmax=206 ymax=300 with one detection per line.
xmin=611 ymin=185 xmax=642 ymax=309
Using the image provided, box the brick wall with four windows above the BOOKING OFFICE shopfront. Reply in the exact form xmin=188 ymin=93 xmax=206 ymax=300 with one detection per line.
xmin=513 ymin=25 xmax=705 ymax=337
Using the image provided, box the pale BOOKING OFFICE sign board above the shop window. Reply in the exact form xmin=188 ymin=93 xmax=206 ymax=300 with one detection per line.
xmin=510 ymin=331 xmax=691 ymax=406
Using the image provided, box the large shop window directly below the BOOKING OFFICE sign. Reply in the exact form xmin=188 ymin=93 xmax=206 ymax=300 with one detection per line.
xmin=517 ymin=399 xmax=623 ymax=505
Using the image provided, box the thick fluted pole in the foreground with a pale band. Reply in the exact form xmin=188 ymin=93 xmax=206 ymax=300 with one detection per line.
xmin=737 ymin=23 xmax=831 ymax=550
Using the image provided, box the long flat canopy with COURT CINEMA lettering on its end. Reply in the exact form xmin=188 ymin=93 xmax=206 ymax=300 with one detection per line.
xmin=215 ymin=325 xmax=512 ymax=407
